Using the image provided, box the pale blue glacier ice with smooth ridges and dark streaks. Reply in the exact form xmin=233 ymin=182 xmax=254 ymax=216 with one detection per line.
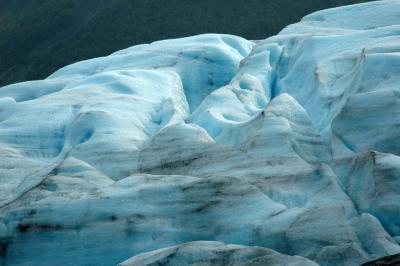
xmin=0 ymin=0 xmax=400 ymax=266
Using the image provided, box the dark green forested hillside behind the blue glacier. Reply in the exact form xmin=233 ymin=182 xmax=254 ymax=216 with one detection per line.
xmin=0 ymin=0 xmax=372 ymax=86
